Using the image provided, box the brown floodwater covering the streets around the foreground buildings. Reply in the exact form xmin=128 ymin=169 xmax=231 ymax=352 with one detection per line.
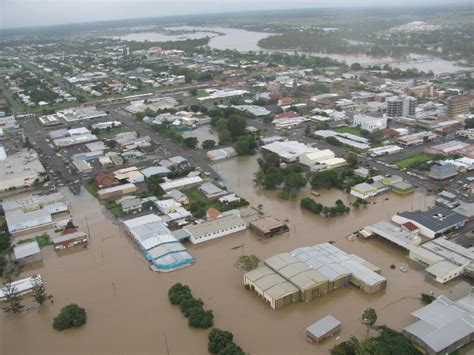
xmin=0 ymin=157 xmax=469 ymax=355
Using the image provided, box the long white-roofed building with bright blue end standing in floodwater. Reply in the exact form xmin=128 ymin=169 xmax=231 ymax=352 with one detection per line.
xmin=123 ymin=214 xmax=195 ymax=272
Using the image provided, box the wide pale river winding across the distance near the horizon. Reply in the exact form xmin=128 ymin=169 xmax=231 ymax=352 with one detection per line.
xmin=111 ymin=26 xmax=469 ymax=74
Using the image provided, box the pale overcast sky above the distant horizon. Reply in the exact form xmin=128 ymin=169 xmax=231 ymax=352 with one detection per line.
xmin=0 ymin=0 xmax=466 ymax=28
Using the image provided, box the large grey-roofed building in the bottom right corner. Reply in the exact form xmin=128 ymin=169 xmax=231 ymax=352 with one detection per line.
xmin=403 ymin=289 xmax=474 ymax=355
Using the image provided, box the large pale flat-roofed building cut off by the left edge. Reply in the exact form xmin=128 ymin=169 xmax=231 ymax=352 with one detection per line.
xmin=0 ymin=151 xmax=46 ymax=192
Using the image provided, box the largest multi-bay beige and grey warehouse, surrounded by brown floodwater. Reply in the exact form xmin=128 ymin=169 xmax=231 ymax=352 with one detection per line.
xmin=244 ymin=243 xmax=387 ymax=309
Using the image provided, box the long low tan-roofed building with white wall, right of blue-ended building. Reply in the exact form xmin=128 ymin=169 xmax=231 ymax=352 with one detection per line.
xmin=183 ymin=215 xmax=247 ymax=244
